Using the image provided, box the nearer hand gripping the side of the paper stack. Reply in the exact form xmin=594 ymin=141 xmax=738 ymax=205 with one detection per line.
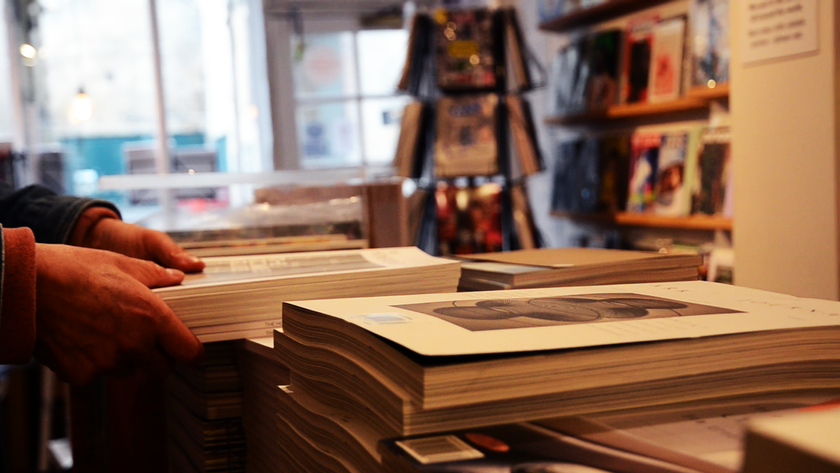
xmin=35 ymin=244 xmax=204 ymax=385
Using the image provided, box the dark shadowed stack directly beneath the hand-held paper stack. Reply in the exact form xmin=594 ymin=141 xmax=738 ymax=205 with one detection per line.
xmin=166 ymin=342 xmax=246 ymax=473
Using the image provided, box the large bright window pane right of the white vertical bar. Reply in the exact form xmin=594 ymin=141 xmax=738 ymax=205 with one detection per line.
xmin=158 ymin=0 xmax=269 ymax=181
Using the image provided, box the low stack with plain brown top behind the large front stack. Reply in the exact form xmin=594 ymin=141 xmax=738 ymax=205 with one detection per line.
xmin=458 ymin=248 xmax=703 ymax=291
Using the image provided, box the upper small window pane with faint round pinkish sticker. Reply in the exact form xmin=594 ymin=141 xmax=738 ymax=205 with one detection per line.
xmin=291 ymin=32 xmax=357 ymax=99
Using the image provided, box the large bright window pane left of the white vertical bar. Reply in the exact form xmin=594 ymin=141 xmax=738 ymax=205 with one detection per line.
xmin=31 ymin=0 xmax=156 ymax=203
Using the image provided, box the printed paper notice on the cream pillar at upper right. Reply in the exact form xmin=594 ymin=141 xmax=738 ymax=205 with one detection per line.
xmin=734 ymin=0 xmax=819 ymax=64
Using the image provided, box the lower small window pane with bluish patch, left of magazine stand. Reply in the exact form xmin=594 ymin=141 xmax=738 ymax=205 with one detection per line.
xmin=297 ymin=101 xmax=361 ymax=168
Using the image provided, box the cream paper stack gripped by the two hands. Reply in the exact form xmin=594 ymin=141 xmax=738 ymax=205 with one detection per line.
xmin=154 ymin=247 xmax=460 ymax=342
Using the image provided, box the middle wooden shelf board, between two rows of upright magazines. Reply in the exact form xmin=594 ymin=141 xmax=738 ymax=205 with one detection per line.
xmin=545 ymin=96 xmax=709 ymax=125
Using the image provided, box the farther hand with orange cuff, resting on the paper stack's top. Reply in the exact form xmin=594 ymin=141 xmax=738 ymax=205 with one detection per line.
xmin=70 ymin=207 xmax=204 ymax=273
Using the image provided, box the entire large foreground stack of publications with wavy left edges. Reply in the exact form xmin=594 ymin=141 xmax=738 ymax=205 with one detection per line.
xmin=274 ymin=281 xmax=840 ymax=473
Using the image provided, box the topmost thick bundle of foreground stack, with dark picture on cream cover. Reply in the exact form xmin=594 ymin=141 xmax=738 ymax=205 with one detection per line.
xmin=283 ymin=281 xmax=840 ymax=409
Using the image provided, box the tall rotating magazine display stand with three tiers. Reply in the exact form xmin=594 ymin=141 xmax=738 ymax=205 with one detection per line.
xmin=394 ymin=8 xmax=544 ymax=255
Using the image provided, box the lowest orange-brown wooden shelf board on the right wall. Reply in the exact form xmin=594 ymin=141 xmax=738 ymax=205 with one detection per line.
xmin=552 ymin=212 xmax=732 ymax=231
